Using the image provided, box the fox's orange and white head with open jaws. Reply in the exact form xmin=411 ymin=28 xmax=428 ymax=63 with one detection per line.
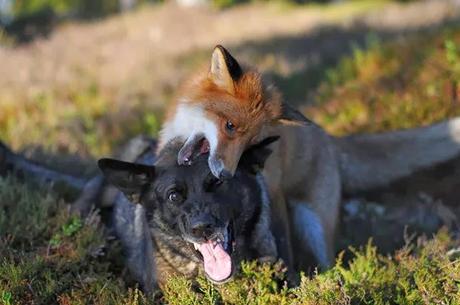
xmin=174 ymin=46 xmax=309 ymax=179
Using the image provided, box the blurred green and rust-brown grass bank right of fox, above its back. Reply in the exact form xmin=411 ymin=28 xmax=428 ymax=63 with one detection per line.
xmin=307 ymin=28 xmax=460 ymax=135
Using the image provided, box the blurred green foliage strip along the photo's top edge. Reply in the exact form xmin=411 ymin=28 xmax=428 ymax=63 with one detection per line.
xmin=0 ymin=0 xmax=420 ymax=41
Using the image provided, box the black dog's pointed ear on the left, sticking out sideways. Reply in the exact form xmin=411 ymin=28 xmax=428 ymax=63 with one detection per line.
xmin=97 ymin=158 xmax=155 ymax=195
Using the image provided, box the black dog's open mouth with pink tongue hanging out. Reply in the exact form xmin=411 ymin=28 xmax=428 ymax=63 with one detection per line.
xmin=192 ymin=224 xmax=235 ymax=284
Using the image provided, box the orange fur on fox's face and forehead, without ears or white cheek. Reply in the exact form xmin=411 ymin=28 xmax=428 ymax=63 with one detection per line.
xmin=170 ymin=63 xmax=282 ymax=147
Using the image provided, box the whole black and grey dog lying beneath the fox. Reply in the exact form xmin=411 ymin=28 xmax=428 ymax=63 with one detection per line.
xmin=0 ymin=137 xmax=278 ymax=292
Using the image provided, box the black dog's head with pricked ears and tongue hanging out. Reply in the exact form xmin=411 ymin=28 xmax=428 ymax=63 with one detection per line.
xmin=98 ymin=138 xmax=275 ymax=283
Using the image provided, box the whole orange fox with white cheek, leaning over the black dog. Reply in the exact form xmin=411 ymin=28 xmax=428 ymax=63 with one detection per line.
xmin=158 ymin=45 xmax=460 ymax=269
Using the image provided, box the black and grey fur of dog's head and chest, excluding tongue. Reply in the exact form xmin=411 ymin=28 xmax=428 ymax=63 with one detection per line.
xmin=99 ymin=141 xmax=277 ymax=284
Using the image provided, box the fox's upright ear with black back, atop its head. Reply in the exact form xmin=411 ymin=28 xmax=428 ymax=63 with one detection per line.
xmin=209 ymin=45 xmax=243 ymax=94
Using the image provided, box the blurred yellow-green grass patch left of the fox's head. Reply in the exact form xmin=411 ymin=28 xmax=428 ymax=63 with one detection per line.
xmin=0 ymin=80 xmax=161 ymax=155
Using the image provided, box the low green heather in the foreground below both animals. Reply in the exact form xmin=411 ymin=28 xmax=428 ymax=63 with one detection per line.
xmin=0 ymin=178 xmax=460 ymax=305
